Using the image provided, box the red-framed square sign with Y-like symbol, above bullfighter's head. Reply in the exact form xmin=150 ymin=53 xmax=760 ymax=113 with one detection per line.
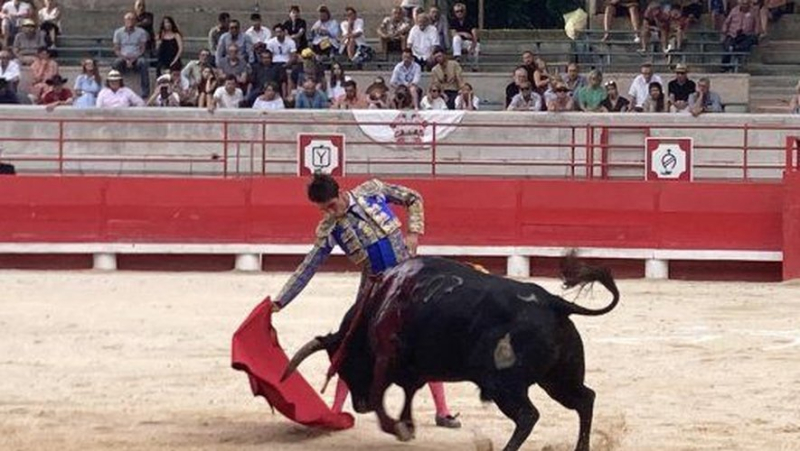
xmin=297 ymin=133 xmax=345 ymax=177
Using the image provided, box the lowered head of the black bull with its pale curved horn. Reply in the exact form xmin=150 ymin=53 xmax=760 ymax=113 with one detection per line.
xmin=281 ymin=311 xmax=375 ymax=413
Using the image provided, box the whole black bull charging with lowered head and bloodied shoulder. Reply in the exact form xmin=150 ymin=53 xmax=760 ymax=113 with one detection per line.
xmin=284 ymin=256 xmax=619 ymax=451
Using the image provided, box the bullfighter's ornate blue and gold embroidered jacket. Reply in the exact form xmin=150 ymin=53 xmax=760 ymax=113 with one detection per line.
xmin=275 ymin=179 xmax=425 ymax=307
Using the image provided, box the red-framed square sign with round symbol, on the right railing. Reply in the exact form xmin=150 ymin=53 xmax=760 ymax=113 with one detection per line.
xmin=644 ymin=138 xmax=694 ymax=182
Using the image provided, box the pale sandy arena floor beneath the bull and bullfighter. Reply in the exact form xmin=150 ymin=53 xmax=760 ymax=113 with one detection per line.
xmin=0 ymin=271 xmax=800 ymax=451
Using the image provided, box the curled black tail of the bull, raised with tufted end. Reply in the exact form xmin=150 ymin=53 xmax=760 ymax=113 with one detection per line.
xmin=559 ymin=250 xmax=619 ymax=316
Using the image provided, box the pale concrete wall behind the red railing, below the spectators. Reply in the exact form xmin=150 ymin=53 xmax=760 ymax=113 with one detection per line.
xmin=0 ymin=107 xmax=800 ymax=179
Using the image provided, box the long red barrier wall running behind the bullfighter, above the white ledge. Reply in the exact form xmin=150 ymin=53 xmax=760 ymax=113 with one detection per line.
xmin=0 ymin=177 xmax=788 ymax=251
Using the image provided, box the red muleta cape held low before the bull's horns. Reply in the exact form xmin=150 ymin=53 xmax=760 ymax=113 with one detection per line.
xmin=231 ymin=298 xmax=354 ymax=430
